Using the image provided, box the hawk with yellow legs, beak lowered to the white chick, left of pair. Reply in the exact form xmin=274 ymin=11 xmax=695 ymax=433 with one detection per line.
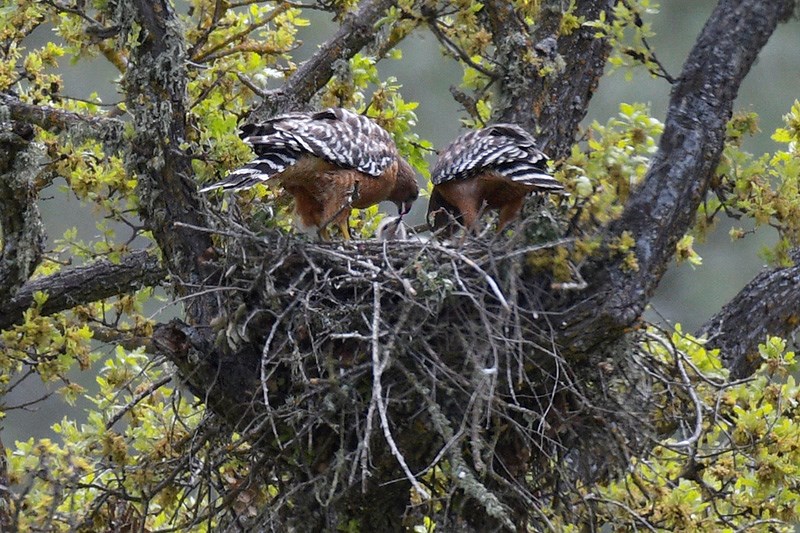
xmin=200 ymin=107 xmax=419 ymax=239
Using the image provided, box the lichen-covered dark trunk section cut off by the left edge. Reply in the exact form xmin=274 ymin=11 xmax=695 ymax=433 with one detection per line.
xmin=0 ymin=123 xmax=45 ymax=302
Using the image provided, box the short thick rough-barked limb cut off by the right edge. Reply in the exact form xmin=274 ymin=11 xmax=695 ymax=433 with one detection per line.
xmin=696 ymin=250 xmax=800 ymax=379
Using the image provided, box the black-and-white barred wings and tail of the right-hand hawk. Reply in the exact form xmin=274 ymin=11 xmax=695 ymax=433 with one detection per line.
xmin=431 ymin=124 xmax=564 ymax=191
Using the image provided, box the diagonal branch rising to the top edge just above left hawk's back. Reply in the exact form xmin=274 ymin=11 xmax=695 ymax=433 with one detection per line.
xmin=253 ymin=0 xmax=395 ymax=119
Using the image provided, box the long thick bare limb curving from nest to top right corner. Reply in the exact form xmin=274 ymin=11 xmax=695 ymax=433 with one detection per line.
xmin=560 ymin=0 xmax=794 ymax=353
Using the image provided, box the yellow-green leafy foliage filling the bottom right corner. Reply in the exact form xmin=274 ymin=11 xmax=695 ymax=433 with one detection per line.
xmin=583 ymin=334 xmax=800 ymax=531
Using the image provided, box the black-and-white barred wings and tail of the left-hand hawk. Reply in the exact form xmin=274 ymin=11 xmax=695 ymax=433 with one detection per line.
xmin=200 ymin=108 xmax=397 ymax=192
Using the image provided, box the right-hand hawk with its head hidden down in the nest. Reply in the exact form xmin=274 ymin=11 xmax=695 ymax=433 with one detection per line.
xmin=428 ymin=124 xmax=564 ymax=232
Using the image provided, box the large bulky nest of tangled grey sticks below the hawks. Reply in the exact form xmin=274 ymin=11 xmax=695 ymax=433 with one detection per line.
xmin=184 ymin=207 xmax=687 ymax=529
